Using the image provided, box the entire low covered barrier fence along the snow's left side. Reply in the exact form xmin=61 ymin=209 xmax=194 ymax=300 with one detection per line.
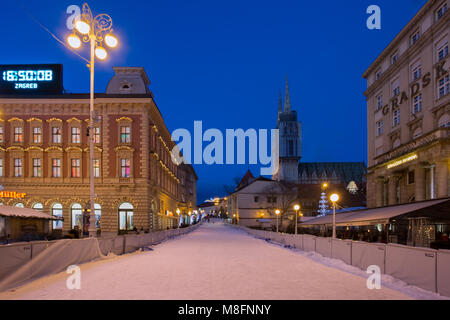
xmin=0 ymin=223 xmax=201 ymax=291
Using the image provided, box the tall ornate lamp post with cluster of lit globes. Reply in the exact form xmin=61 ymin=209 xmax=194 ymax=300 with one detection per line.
xmin=67 ymin=3 xmax=118 ymax=237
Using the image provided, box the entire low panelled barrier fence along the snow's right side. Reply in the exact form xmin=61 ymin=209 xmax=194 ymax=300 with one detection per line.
xmin=231 ymin=225 xmax=450 ymax=297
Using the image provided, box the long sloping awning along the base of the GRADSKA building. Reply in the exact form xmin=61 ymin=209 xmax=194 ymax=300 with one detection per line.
xmin=300 ymin=198 xmax=450 ymax=227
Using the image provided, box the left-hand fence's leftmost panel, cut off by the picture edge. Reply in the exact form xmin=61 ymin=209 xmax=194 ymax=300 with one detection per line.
xmin=0 ymin=242 xmax=31 ymax=282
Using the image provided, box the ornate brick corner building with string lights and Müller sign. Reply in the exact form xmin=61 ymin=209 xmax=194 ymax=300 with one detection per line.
xmin=0 ymin=67 xmax=196 ymax=235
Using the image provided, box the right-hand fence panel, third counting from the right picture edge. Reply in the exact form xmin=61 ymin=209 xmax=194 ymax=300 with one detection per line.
xmin=352 ymin=241 xmax=386 ymax=273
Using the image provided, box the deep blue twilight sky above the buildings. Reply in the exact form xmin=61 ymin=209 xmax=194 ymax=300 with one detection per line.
xmin=0 ymin=0 xmax=426 ymax=201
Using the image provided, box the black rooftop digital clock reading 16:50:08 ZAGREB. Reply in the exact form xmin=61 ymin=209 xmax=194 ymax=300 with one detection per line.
xmin=0 ymin=64 xmax=63 ymax=95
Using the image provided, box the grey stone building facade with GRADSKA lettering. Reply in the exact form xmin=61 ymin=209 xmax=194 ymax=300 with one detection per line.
xmin=363 ymin=0 xmax=450 ymax=207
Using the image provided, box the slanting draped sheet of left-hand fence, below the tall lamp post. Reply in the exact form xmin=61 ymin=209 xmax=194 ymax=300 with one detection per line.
xmin=0 ymin=238 xmax=104 ymax=291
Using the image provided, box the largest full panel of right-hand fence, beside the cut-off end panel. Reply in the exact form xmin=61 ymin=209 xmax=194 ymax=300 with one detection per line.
xmin=386 ymin=243 xmax=437 ymax=292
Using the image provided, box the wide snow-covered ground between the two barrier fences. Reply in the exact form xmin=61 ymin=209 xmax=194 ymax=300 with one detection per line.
xmin=0 ymin=222 xmax=442 ymax=300
